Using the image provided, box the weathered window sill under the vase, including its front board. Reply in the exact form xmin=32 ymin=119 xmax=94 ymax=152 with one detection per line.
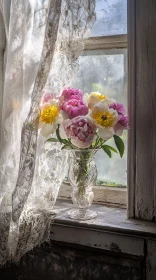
xmin=51 ymin=200 xmax=156 ymax=256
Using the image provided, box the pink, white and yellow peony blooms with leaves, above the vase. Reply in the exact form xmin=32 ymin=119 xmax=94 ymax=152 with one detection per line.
xmin=40 ymin=88 xmax=128 ymax=157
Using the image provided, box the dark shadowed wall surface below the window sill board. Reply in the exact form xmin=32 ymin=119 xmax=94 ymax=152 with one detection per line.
xmin=0 ymin=242 xmax=143 ymax=280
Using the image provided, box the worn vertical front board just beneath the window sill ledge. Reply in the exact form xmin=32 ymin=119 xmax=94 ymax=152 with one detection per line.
xmin=51 ymin=224 xmax=144 ymax=256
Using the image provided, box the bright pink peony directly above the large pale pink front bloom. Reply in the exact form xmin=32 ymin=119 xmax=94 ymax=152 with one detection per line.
xmin=60 ymin=99 xmax=88 ymax=119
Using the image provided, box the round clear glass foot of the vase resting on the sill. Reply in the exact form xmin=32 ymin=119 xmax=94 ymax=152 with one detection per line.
xmin=68 ymin=209 xmax=97 ymax=221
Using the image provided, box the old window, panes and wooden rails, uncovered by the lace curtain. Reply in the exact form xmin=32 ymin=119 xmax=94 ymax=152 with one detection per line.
xmin=60 ymin=0 xmax=127 ymax=205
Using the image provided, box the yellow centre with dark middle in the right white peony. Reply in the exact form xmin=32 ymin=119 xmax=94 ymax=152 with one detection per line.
xmin=93 ymin=111 xmax=114 ymax=127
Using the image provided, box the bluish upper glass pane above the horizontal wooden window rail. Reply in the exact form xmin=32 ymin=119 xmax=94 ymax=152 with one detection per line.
xmin=91 ymin=0 xmax=127 ymax=37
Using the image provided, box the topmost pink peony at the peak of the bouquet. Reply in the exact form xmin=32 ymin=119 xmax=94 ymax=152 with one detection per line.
xmin=60 ymin=88 xmax=83 ymax=101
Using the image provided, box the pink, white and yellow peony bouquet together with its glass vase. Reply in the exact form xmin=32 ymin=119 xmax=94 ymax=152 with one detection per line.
xmin=40 ymin=88 xmax=128 ymax=217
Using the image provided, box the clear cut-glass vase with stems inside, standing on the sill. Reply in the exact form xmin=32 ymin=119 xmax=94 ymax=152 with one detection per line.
xmin=68 ymin=150 xmax=97 ymax=220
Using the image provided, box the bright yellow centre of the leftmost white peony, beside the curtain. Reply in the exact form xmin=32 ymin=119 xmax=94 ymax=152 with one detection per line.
xmin=40 ymin=105 xmax=59 ymax=124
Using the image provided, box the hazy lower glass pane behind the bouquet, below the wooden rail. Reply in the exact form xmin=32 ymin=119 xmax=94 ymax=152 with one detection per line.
xmin=74 ymin=50 xmax=127 ymax=186
